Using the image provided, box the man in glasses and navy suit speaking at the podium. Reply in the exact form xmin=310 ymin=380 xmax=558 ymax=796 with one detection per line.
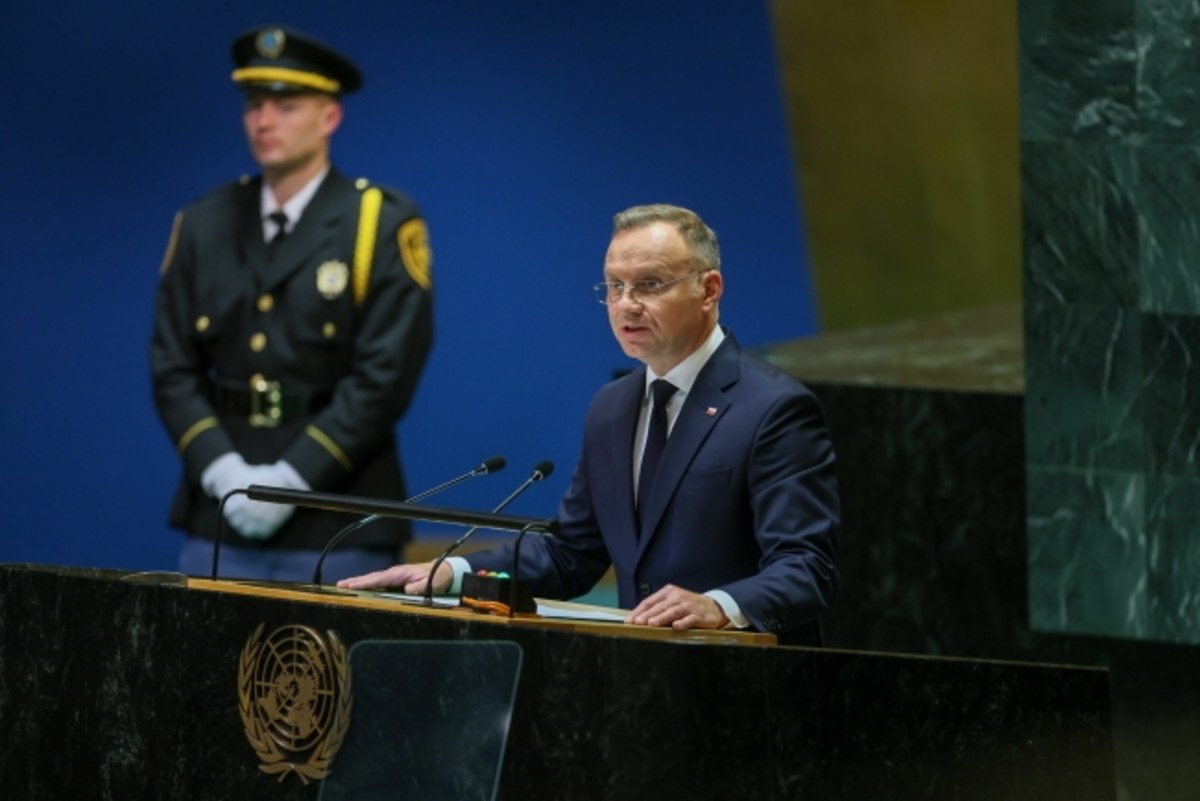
xmin=340 ymin=205 xmax=840 ymax=644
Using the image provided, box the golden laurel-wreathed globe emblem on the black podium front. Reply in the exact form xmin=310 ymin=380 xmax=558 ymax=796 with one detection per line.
xmin=238 ymin=624 xmax=353 ymax=784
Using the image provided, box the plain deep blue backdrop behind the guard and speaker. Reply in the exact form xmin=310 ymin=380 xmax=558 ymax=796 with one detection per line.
xmin=0 ymin=0 xmax=816 ymax=570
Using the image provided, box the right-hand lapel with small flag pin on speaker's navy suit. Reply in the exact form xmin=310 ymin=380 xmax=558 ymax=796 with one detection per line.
xmin=638 ymin=336 xmax=740 ymax=552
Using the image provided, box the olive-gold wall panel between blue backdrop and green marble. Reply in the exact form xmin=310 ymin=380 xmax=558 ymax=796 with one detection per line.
xmin=773 ymin=0 xmax=1021 ymax=331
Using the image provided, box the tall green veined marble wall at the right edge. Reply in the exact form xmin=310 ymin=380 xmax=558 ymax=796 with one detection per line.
xmin=1019 ymin=0 xmax=1200 ymax=644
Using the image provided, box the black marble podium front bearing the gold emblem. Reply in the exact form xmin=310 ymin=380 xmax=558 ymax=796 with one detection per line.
xmin=0 ymin=565 xmax=1115 ymax=801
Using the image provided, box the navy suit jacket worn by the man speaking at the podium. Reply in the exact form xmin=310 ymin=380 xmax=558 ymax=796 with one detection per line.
xmin=467 ymin=336 xmax=840 ymax=643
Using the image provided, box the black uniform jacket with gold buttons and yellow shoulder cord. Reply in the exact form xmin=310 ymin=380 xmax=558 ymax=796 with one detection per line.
xmin=151 ymin=164 xmax=433 ymax=548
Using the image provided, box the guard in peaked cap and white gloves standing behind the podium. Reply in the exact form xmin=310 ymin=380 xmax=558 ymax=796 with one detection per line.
xmin=151 ymin=21 xmax=433 ymax=580
